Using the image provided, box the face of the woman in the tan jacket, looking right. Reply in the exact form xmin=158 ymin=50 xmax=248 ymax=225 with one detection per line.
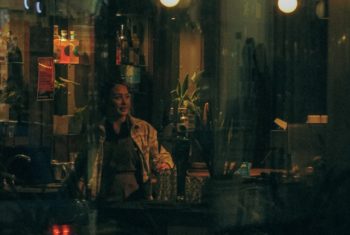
xmin=111 ymin=84 xmax=131 ymax=118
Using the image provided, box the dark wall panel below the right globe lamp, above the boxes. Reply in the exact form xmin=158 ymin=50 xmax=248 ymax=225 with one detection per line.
xmin=274 ymin=0 xmax=328 ymax=123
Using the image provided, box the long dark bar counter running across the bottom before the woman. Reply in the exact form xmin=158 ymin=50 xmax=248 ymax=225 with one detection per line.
xmin=0 ymin=169 xmax=314 ymax=235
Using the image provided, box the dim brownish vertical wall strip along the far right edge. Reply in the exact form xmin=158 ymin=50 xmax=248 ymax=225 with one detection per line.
xmin=328 ymin=0 xmax=350 ymax=167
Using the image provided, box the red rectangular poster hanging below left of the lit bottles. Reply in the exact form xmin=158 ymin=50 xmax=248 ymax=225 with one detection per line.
xmin=37 ymin=57 xmax=55 ymax=101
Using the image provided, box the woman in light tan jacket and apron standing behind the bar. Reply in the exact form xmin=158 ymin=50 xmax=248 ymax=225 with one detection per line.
xmin=90 ymin=81 xmax=174 ymax=201
